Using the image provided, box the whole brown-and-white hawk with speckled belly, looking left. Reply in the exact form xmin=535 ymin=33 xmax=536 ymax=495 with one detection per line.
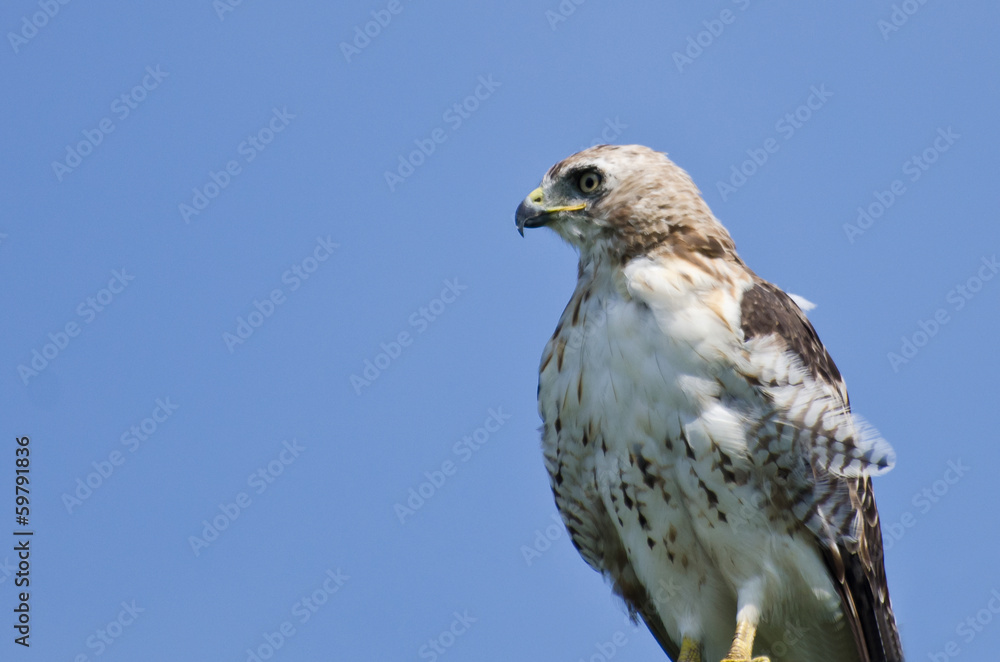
xmin=516 ymin=145 xmax=903 ymax=662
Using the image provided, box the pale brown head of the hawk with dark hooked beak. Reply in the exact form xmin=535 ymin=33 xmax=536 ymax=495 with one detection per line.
xmin=514 ymin=145 xmax=738 ymax=260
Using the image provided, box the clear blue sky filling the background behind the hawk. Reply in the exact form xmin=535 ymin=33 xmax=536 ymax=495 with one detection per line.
xmin=0 ymin=0 xmax=1000 ymax=662
